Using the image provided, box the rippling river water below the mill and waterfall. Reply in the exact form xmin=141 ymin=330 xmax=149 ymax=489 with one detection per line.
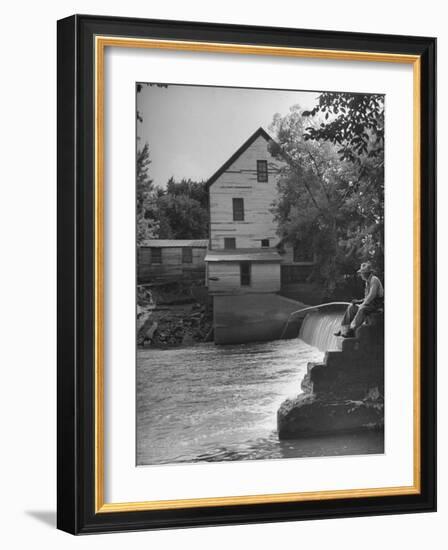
xmin=137 ymin=339 xmax=382 ymax=465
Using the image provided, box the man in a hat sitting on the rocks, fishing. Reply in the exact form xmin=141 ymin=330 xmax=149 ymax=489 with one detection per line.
xmin=335 ymin=262 xmax=384 ymax=338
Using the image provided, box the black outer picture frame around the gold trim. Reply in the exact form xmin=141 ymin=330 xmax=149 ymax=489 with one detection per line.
xmin=57 ymin=15 xmax=436 ymax=534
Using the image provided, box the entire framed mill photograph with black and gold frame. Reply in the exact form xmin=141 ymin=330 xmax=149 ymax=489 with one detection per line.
xmin=58 ymin=15 xmax=436 ymax=534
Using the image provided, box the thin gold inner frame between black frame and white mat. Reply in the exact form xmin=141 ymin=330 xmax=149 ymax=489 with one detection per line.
xmin=94 ymin=36 xmax=421 ymax=513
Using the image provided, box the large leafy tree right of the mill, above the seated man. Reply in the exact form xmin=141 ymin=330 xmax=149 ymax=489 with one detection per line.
xmin=271 ymin=99 xmax=384 ymax=296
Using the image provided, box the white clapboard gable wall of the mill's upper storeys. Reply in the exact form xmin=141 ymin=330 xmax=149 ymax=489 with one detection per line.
xmin=209 ymin=136 xmax=281 ymax=249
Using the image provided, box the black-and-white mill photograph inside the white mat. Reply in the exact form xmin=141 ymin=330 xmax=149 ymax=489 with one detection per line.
xmin=136 ymin=82 xmax=385 ymax=466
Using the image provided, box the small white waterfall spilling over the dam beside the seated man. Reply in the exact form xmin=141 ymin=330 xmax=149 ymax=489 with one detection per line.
xmin=299 ymin=310 xmax=344 ymax=351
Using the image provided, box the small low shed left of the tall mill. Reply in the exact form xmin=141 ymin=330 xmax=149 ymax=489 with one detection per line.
xmin=137 ymin=239 xmax=208 ymax=282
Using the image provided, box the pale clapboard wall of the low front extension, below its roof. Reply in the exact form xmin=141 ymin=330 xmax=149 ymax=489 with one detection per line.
xmin=208 ymin=262 xmax=280 ymax=294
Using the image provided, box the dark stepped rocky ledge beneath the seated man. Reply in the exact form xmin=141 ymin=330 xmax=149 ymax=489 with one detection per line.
xmin=277 ymin=315 xmax=384 ymax=439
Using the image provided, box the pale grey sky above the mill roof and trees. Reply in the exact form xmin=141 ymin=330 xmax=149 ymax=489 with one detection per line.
xmin=137 ymin=84 xmax=318 ymax=187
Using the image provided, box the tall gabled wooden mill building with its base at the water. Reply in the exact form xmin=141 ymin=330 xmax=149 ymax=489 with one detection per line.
xmin=205 ymin=128 xmax=313 ymax=343
